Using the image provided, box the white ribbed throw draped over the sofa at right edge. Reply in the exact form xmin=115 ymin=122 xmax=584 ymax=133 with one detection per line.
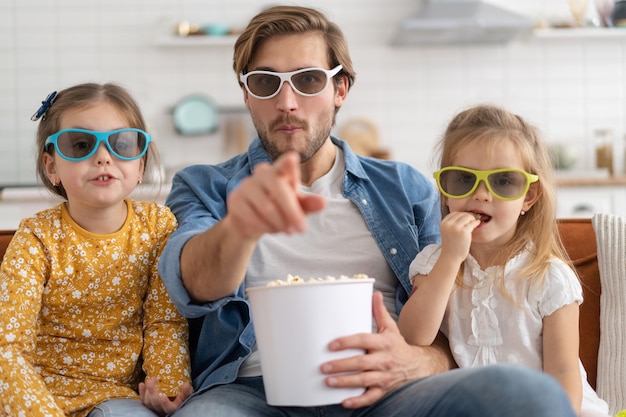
xmin=592 ymin=213 xmax=626 ymax=414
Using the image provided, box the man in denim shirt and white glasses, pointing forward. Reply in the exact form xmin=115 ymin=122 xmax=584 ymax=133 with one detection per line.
xmin=152 ymin=6 xmax=573 ymax=417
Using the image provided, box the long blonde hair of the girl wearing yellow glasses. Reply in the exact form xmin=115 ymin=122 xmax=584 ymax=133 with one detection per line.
xmin=437 ymin=105 xmax=570 ymax=290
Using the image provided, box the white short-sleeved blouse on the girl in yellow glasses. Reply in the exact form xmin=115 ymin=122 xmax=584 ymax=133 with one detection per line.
xmin=409 ymin=244 xmax=608 ymax=415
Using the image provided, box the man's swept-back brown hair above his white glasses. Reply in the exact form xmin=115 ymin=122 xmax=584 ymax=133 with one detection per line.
xmin=233 ymin=6 xmax=356 ymax=88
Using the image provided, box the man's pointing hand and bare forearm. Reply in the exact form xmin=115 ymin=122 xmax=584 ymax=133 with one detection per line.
xmin=180 ymin=152 xmax=326 ymax=303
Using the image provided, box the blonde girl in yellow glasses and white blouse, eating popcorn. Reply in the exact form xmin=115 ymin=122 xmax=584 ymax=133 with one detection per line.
xmin=398 ymin=106 xmax=608 ymax=416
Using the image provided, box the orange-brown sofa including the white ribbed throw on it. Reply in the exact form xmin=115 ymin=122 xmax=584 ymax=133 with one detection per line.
xmin=0 ymin=215 xmax=626 ymax=414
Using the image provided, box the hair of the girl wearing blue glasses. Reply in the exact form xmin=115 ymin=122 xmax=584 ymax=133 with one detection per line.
xmin=36 ymin=83 xmax=159 ymax=199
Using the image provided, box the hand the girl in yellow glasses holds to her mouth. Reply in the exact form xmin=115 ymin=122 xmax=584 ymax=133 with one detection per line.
xmin=440 ymin=211 xmax=480 ymax=262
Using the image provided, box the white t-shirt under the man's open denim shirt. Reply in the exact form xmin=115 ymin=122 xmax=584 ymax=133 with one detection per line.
xmin=239 ymin=147 xmax=398 ymax=376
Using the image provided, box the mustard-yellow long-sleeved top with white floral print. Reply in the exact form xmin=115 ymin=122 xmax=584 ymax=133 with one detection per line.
xmin=0 ymin=200 xmax=190 ymax=417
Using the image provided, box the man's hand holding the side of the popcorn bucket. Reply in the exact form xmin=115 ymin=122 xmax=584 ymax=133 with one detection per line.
xmin=321 ymin=292 xmax=452 ymax=408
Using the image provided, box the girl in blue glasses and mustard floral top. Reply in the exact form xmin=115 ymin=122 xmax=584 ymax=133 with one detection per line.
xmin=0 ymin=84 xmax=191 ymax=417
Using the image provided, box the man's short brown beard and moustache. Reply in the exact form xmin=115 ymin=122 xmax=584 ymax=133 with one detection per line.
xmin=250 ymin=108 xmax=337 ymax=162
